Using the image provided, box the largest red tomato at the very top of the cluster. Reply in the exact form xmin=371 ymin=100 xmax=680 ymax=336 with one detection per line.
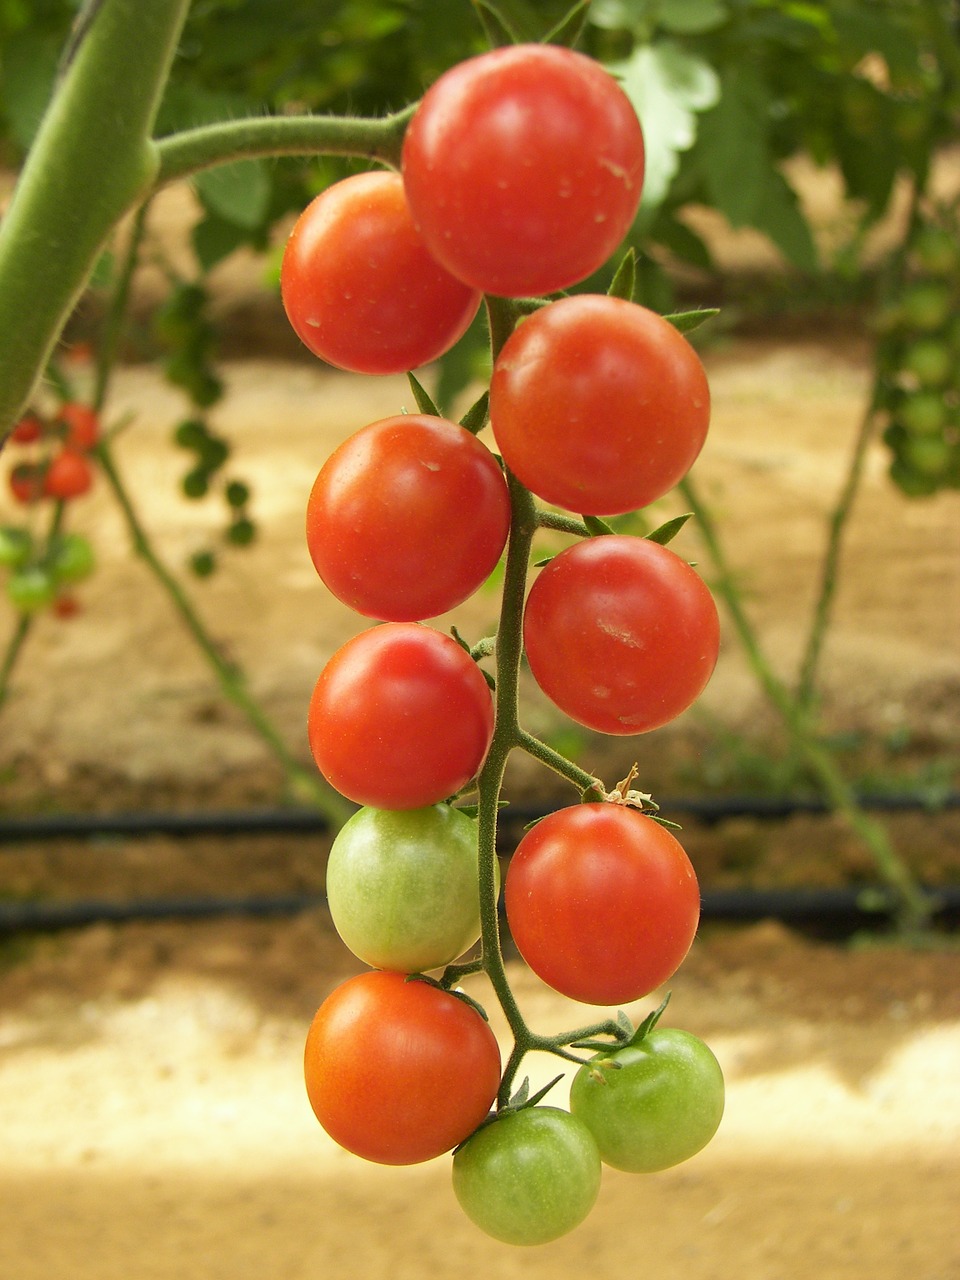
xmin=402 ymin=45 xmax=644 ymax=297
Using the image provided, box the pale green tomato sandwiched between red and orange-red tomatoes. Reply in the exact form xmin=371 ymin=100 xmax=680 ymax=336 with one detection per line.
xmin=326 ymin=804 xmax=499 ymax=973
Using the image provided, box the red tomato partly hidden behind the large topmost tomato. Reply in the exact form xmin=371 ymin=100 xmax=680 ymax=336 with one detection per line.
xmin=280 ymin=173 xmax=480 ymax=374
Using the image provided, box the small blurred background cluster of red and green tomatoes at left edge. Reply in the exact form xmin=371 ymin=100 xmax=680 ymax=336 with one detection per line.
xmin=0 ymin=401 xmax=100 ymax=617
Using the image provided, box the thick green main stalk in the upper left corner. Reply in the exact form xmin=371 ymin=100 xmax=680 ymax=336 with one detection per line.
xmin=0 ymin=0 xmax=189 ymax=440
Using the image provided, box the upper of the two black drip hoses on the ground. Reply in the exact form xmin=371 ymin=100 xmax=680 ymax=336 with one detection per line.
xmin=0 ymin=791 xmax=960 ymax=845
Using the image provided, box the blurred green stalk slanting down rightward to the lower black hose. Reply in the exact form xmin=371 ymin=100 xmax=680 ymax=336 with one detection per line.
xmin=680 ymin=476 xmax=933 ymax=936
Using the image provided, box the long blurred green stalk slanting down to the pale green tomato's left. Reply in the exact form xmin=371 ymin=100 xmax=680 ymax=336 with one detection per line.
xmin=97 ymin=443 xmax=353 ymax=826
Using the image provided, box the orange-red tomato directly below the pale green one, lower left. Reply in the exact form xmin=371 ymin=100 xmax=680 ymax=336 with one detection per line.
xmin=303 ymin=970 xmax=500 ymax=1165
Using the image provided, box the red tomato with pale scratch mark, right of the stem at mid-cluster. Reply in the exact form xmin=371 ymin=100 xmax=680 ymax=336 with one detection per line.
xmin=524 ymin=534 xmax=719 ymax=735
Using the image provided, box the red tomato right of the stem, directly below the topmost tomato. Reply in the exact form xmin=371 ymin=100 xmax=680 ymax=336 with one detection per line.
xmin=490 ymin=294 xmax=710 ymax=516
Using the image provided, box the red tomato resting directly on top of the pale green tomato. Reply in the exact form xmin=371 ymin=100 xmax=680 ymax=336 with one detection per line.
xmin=307 ymin=622 xmax=493 ymax=809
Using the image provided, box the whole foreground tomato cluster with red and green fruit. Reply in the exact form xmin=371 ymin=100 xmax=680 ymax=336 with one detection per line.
xmin=289 ymin=45 xmax=723 ymax=1244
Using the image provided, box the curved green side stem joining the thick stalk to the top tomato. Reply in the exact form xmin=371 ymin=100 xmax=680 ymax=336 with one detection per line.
xmin=156 ymin=104 xmax=416 ymax=188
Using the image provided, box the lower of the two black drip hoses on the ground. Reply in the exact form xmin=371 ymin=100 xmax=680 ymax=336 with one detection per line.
xmin=0 ymin=886 xmax=960 ymax=936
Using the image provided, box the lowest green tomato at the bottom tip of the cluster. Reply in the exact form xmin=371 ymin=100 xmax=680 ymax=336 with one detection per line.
xmin=453 ymin=1107 xmax=600 ymax=1244
